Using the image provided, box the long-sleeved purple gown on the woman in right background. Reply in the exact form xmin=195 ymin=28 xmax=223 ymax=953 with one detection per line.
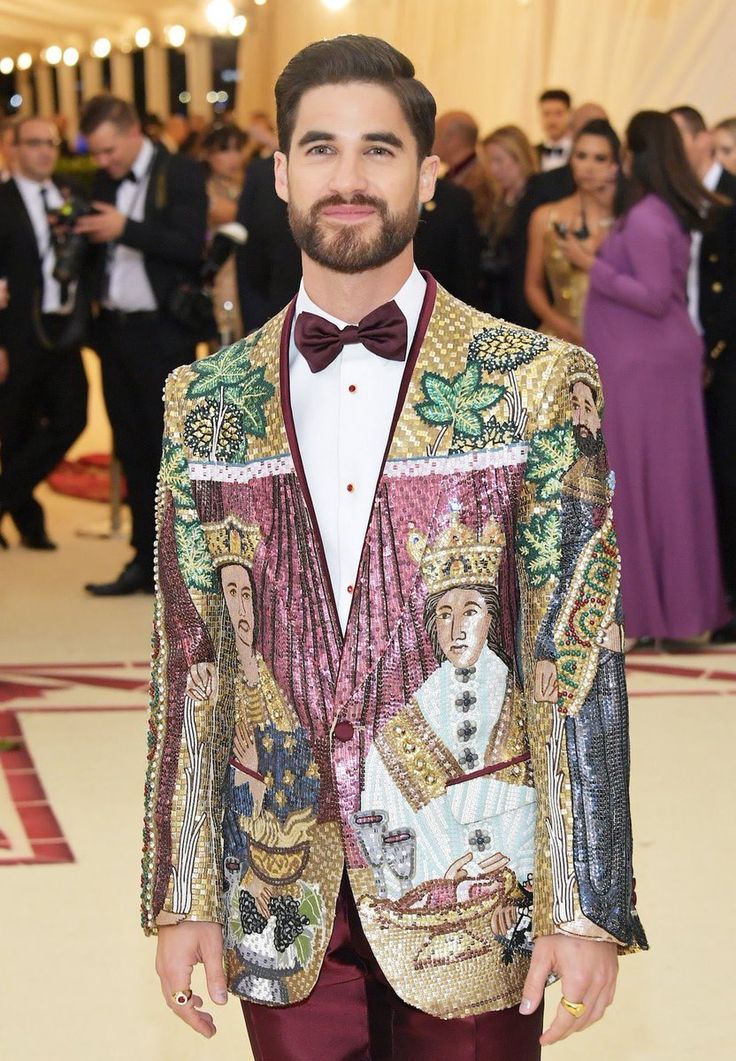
xmin=583 ymin=195 xmax=736 ymax=639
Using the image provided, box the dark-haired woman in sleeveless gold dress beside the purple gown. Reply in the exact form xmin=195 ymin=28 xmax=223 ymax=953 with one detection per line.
xmin=525 ymin=118 xmax=620 ymax=345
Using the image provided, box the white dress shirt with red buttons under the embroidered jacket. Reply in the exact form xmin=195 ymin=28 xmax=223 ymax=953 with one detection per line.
xmin=288 ymin=266 xmax=426 ymax=631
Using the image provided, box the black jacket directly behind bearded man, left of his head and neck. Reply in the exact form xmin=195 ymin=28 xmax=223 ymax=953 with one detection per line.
xmin=235 ymin=158 xmax=301 ymax=332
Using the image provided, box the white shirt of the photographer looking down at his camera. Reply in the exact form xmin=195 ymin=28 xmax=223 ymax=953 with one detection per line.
xmin=105 ymin=139 xmax=157 ymax=313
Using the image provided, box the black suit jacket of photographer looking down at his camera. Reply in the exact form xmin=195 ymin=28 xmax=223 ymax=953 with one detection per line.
xmin=91 ymin=144 xmax=207 ymax=313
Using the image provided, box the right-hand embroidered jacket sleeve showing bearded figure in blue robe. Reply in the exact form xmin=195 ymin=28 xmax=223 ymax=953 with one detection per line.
xmin=516 ymin=344 xmax=647 ymax=947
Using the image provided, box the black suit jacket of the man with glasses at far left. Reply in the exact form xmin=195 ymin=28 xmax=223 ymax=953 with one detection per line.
xmin=0 ymin=178 xmax=87 ymax=362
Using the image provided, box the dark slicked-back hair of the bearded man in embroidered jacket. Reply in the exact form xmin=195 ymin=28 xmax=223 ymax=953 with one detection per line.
xmin=276 ymin=34 xmax=437 ymax=160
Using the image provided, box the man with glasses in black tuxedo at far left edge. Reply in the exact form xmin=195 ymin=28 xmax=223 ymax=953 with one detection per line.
xmin=0 ymin=118 xmax=89 ymax=550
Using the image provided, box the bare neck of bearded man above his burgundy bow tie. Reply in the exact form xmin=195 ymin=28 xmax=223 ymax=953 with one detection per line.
xmin=301 ymin=243 xmax=414 ymax=325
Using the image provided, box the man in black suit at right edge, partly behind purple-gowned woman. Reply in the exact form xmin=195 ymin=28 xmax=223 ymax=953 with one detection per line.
xmin=669 ymin=105 xmax=736 ymax=619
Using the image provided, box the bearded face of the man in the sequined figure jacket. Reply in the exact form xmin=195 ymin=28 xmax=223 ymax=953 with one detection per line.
xmin=275 ymin=83 xmax=438 ymax=273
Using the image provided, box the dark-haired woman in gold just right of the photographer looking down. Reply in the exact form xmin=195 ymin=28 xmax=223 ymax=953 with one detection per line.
xmin=201 ymin=123 xmax=247 ymax=342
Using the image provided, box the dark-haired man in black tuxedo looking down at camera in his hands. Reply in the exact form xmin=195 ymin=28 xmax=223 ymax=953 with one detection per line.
xmin=77 ymin=95 xmax=209 ymax=596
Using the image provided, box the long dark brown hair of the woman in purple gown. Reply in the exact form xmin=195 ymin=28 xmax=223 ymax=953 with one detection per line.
xmin=626 ymin=110 xmax=722 ymax=232
